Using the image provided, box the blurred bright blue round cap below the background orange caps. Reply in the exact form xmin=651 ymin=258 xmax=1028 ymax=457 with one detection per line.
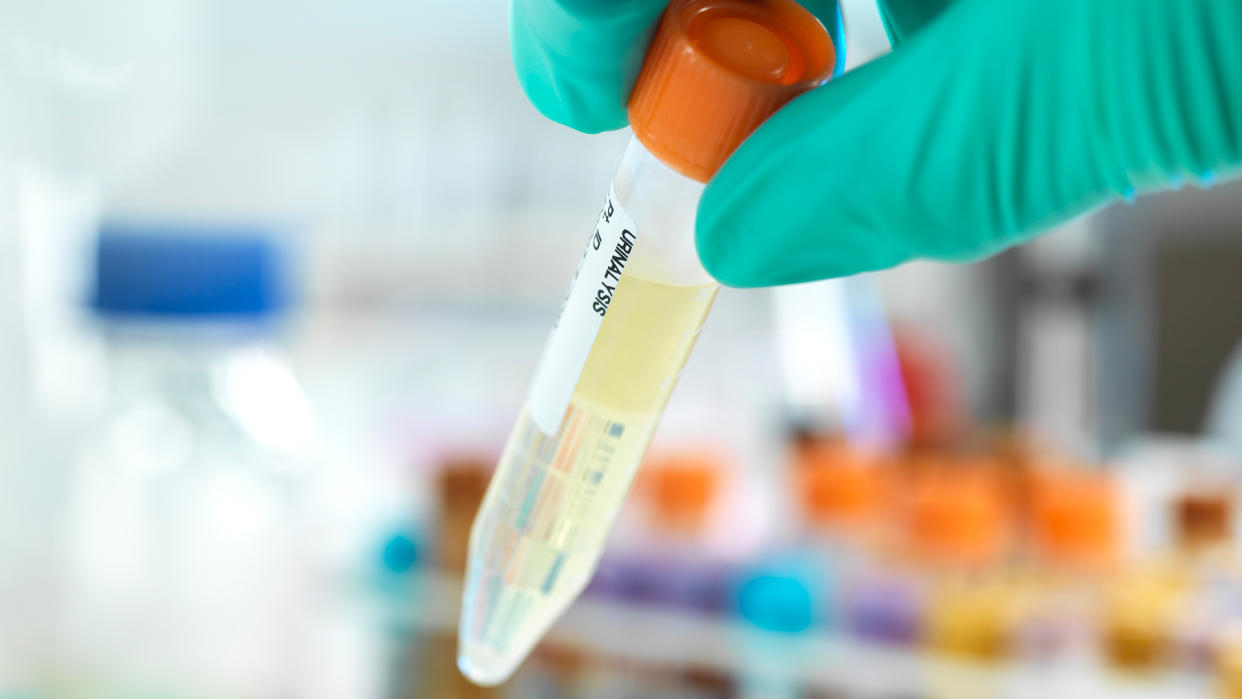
xmin=735 ymin=555 xmax=831 ymax=633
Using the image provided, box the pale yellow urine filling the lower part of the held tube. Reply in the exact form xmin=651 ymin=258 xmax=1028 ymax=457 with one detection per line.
xmin=458 ymin=272 xmax=719 ymax=683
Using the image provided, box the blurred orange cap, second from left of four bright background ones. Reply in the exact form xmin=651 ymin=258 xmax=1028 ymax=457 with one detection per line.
xmin=794 ymin=441 xmax=888 ymax=529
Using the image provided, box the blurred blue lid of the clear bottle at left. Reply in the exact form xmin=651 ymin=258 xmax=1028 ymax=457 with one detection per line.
xmin=91 ymin=222 xmax=288 ymax=322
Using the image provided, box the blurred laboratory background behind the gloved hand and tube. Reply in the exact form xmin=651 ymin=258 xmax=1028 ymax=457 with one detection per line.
xmin=7 ymin=0 xmax=1242 ymax=699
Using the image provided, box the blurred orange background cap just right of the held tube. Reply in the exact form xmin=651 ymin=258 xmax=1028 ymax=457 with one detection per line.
xmin=641 ymin=452 xmax=722 ymax=531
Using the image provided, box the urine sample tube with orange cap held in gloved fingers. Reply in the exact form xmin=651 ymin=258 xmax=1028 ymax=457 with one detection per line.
xmin=457 ymin=0 xmax=835 ymax=684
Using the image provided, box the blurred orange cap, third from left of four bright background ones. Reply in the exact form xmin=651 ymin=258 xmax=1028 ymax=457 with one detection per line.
xmin=905 ymin=464 xmax=1010 ymax=567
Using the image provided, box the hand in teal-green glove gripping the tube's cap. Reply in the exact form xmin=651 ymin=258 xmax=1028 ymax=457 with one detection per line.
xmin=510 ymin=0 xmax=1242 ymax=287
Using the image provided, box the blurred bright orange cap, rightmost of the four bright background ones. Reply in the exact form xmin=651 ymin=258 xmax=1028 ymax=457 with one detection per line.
xmin=1030 ymin=468 xmax=1122 ymax=570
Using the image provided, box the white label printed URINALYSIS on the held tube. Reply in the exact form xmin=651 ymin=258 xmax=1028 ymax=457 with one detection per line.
xmin=527 ymin=190 xmax=638 ymax=435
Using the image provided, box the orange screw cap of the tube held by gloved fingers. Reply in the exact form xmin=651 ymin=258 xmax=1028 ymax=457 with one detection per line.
xmin=630 ymin=0 xmax=836 ymax=183
